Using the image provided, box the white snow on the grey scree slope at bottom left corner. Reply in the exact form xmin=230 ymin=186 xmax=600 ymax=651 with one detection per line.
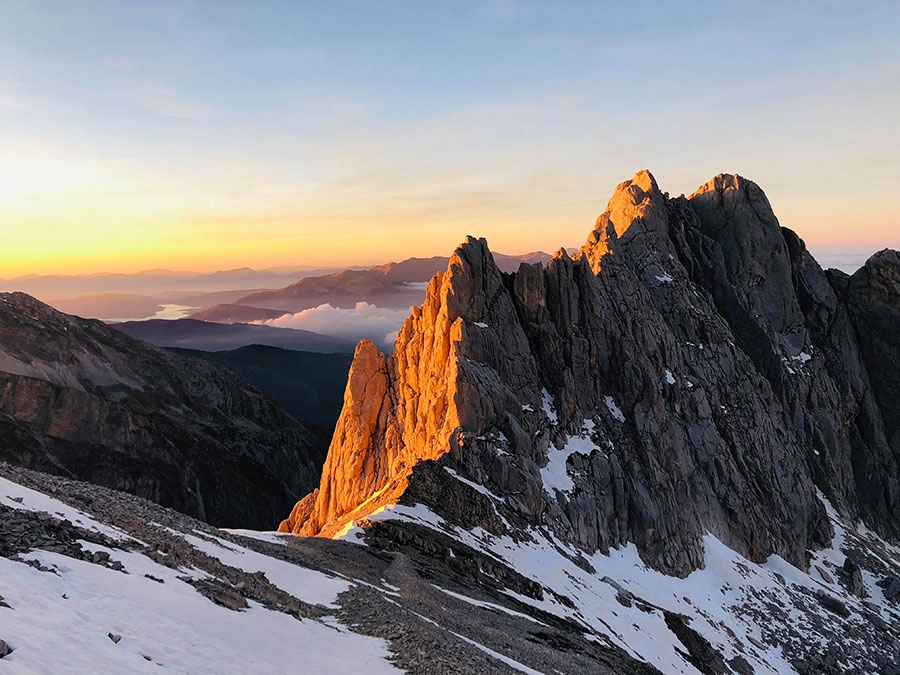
xmin=0 ymin=472 xmax=398 ymax=673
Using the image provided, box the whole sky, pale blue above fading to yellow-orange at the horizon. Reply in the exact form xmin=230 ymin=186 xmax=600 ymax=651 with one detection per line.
xmin=0 ymin=0 xmax=900 ymax=278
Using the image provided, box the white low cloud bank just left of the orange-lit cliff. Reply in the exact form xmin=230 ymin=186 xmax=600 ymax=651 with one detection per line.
xmin=259 ymin=302 xmax=409 ymax=346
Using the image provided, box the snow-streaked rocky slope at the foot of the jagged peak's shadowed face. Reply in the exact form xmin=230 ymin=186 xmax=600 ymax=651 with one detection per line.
xmin=356 ymin=476 xmax=900 ymax=674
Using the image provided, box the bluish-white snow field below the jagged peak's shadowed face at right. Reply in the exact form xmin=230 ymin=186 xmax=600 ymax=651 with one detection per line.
xmin=368 ymin=494 xmax=900 ymax=674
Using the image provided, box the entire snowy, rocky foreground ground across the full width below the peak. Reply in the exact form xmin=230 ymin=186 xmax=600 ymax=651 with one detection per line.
xmin=0 ymin=456 xmax=900 ymax=675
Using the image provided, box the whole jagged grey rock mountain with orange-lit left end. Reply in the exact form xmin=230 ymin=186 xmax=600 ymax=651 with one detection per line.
xmin=282 ymin=171 xmax=900 ymax=575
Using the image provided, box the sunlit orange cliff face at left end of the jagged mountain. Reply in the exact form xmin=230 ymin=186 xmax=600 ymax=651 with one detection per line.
xmin=282 ymin=246 xmax=468 ymax=536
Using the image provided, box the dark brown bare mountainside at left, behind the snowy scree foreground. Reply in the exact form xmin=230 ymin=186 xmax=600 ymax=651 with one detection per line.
xmin=0 ymin=293 xmax=322 ymax=527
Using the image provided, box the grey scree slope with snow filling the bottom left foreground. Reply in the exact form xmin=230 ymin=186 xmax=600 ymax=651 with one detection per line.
xmin=0 ymin=462 xmax=658 ymax=675
